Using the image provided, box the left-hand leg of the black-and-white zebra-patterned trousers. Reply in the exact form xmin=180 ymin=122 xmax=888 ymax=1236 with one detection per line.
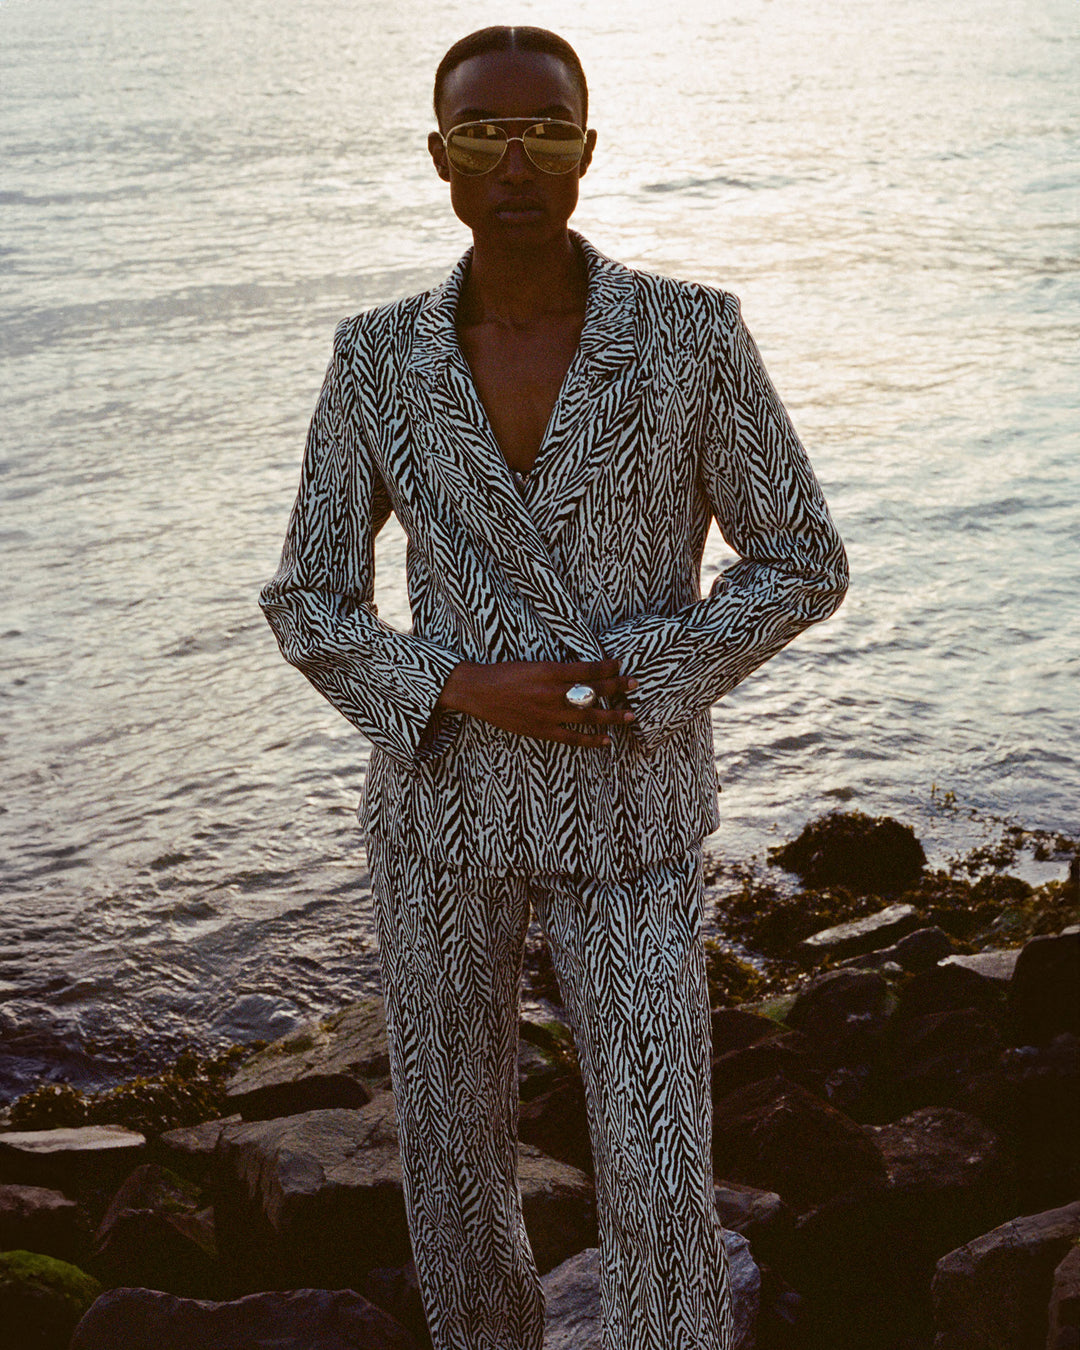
xmin=370 ymin=846 xmax=544 ymax=1350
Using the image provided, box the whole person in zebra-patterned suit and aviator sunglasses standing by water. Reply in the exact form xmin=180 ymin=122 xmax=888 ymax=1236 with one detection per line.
xmin=263 ymin=28 xmax=846 ymax=1350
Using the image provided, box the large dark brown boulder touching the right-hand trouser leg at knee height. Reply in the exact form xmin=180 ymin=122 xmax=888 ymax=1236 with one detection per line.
xmin=713 ymin=1077 xmax=884 ymax=1210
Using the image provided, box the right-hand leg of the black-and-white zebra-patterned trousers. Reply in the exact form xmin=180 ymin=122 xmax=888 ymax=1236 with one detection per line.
xmin=532 ymin=849 xmax=732 ymax=1350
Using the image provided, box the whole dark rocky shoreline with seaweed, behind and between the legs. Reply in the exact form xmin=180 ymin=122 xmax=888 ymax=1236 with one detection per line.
xmin=0 ymin=813 xmax=1080 ymax=1350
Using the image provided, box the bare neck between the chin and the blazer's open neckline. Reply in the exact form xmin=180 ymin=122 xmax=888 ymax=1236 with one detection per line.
xmin=458 ymin=234 xmax=587 ymax=328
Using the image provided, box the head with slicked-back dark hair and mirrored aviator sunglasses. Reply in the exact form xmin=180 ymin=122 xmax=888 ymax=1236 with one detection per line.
xmin=428 ymin=28 xmax=597 ymax=246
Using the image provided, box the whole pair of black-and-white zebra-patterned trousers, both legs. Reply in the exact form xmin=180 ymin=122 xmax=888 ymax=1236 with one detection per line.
xmin=370 ymin=841 xmax=732 ymax=1350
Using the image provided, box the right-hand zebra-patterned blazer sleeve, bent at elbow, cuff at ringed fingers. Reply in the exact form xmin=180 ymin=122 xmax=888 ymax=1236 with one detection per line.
xmin=601 ymin=294 xmax=848 ymax=751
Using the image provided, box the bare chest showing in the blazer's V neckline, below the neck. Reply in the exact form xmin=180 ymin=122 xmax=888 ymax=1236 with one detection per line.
xmin=458 ymin=315 xmax=582 ymax=475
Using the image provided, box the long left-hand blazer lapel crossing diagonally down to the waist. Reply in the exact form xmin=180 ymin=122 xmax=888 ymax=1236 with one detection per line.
xmin=402 ymin=251 xmax=603 ymax=660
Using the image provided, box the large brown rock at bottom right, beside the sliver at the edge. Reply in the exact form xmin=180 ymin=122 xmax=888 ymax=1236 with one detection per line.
xmin=933 ymin=1202 xmax=1080 ymax=1350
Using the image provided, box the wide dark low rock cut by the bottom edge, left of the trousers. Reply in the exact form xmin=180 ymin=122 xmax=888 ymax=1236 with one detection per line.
xmin=70 ymin=1289 xmax=417 ymax=1350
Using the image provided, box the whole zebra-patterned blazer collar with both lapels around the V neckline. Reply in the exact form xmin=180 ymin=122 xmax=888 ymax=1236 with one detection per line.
xmin=402 ymin=235 xmax=640 ymax=660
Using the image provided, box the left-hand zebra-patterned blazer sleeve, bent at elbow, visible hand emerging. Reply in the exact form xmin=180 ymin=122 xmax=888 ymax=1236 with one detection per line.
xmin=259 ymin=320 xmax=460 ymax=763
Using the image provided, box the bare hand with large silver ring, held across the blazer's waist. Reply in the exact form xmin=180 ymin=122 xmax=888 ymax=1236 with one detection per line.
xmin=437 ymin=660 xmax=637 ymax=745
